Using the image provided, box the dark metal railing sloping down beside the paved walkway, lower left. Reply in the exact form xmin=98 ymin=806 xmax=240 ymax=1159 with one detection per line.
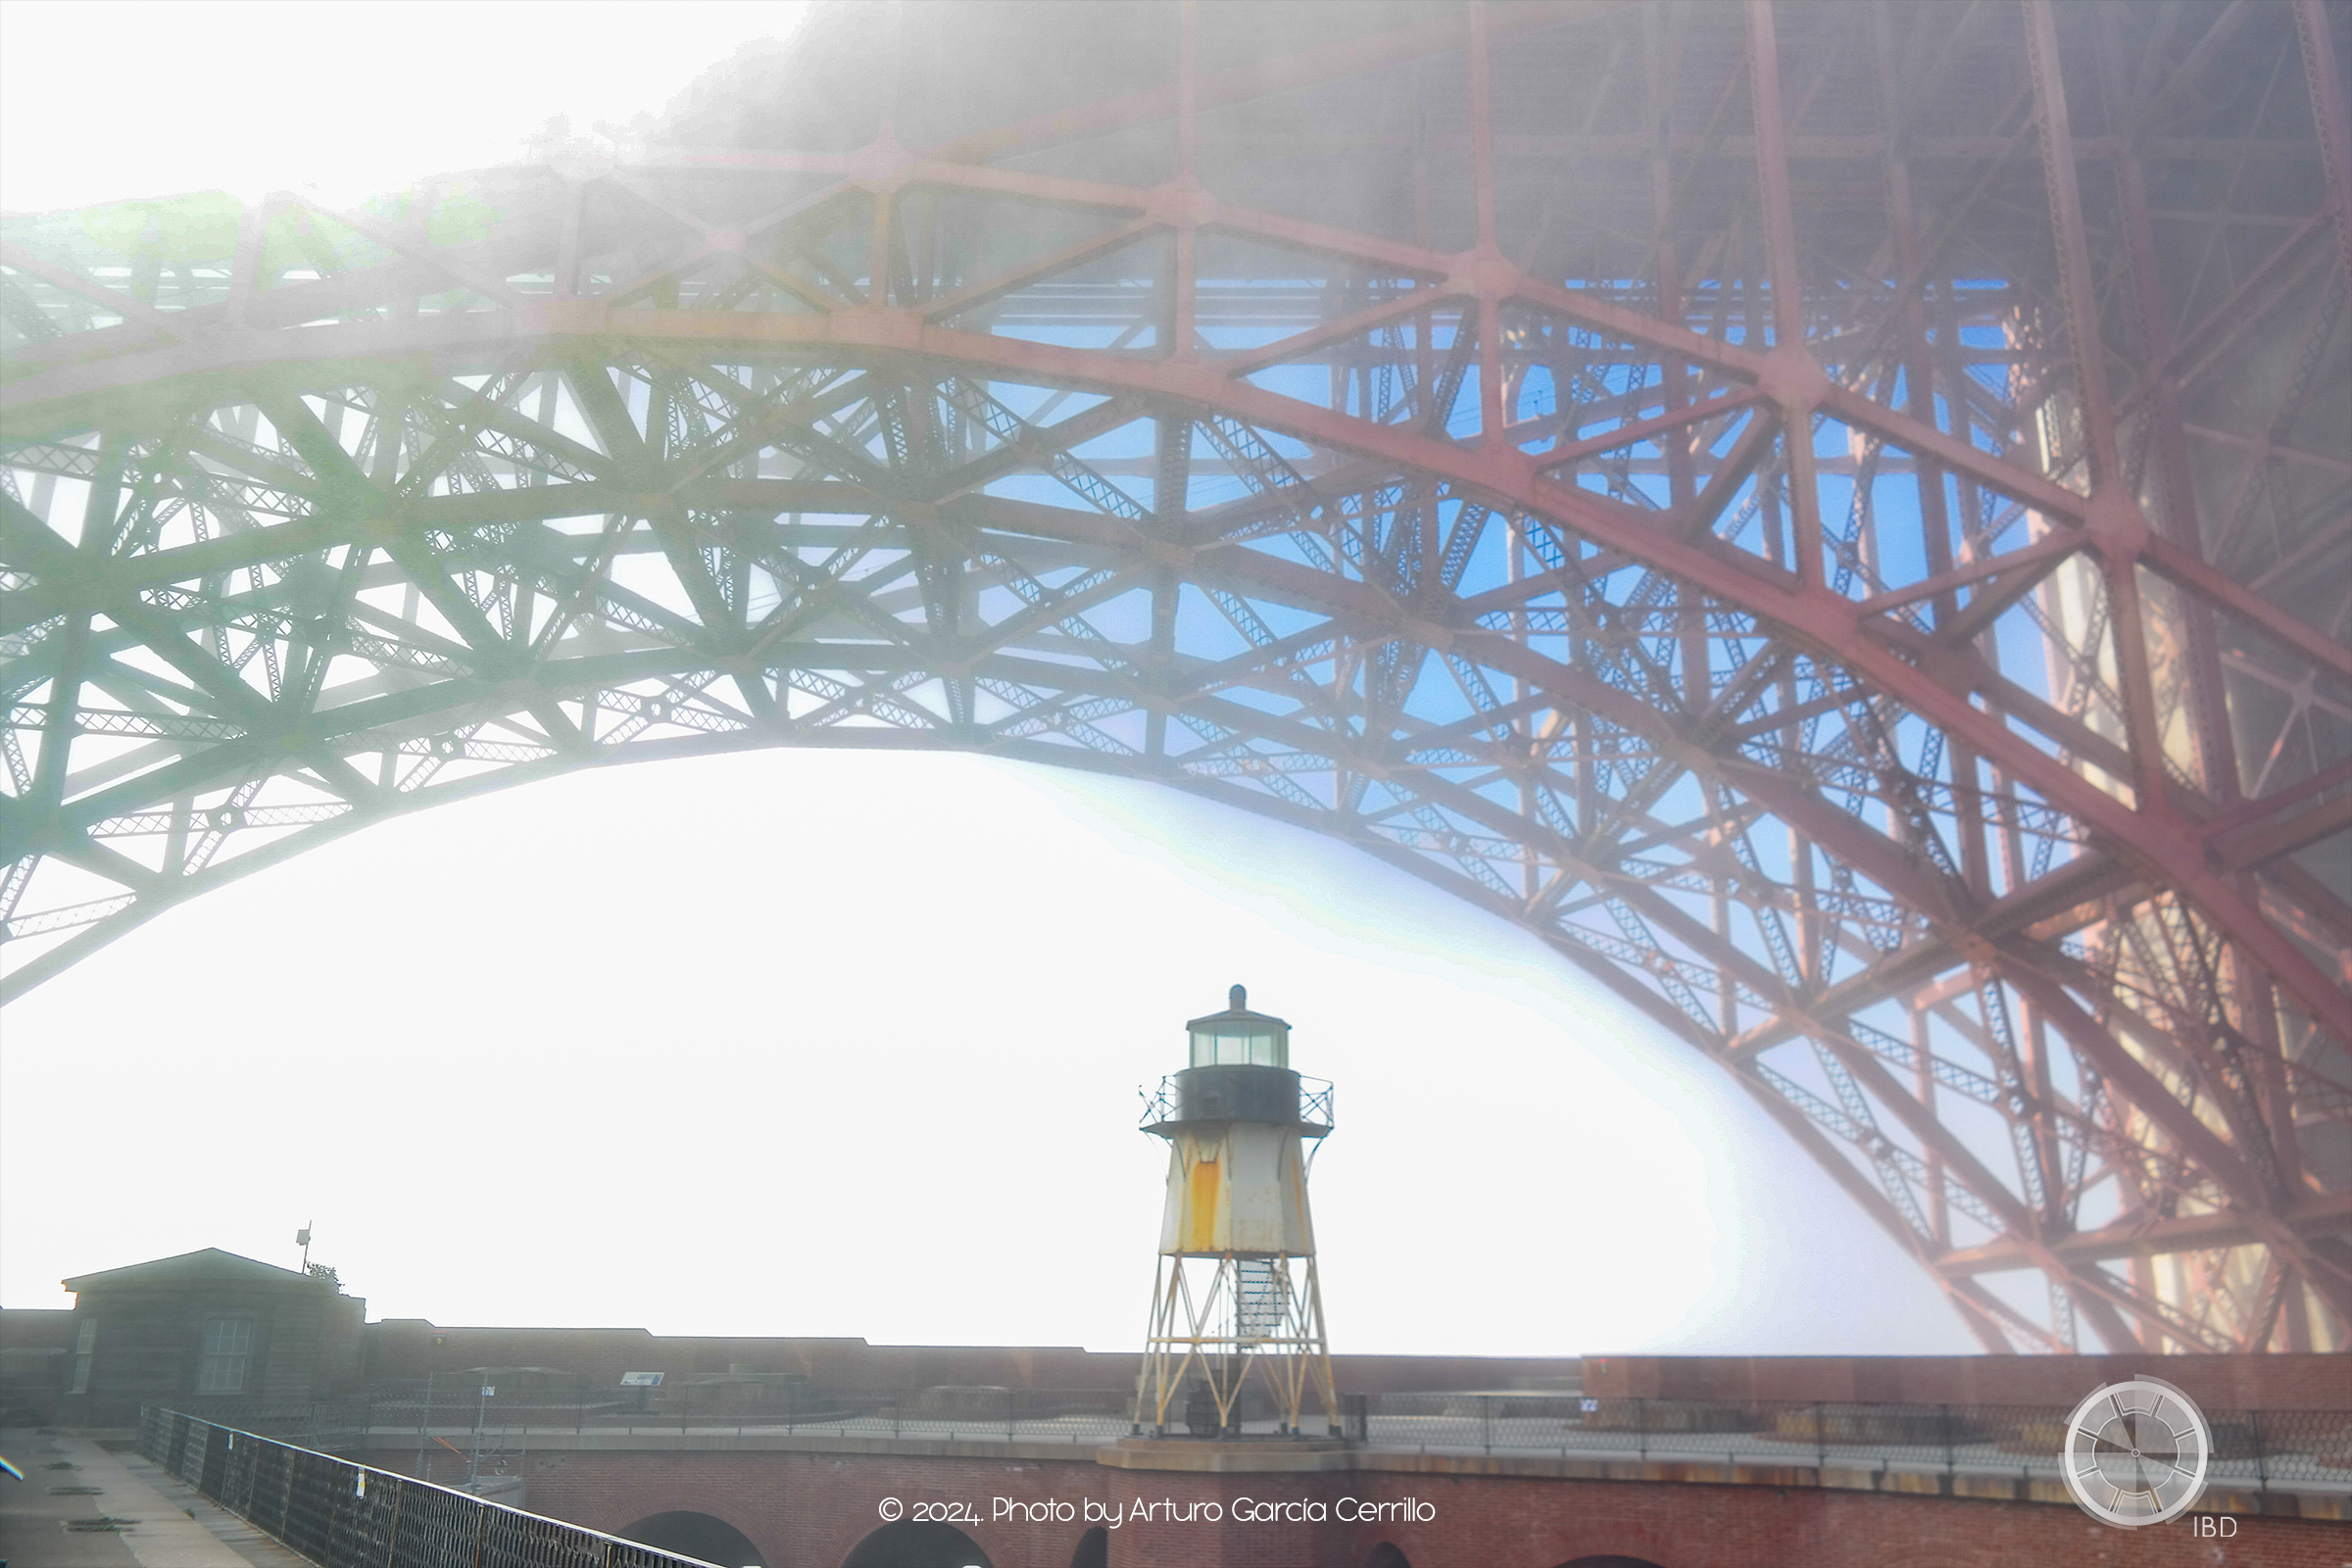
xmin=139 ymin=1408 xmax=708 ymax=1568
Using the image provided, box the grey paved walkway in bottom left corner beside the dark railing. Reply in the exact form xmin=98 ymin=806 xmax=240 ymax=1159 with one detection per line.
xmin=0 ymin=1427 xmax=311 ymax=1568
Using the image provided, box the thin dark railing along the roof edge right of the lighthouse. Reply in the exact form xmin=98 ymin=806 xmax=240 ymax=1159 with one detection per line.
xmin=1346 ymin=1394 xmax=2352 ymax=1493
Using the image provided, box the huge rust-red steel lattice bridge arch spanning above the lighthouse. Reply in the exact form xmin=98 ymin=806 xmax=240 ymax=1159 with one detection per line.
xmin=0 ymin=0 xmax=2352 ymax=1349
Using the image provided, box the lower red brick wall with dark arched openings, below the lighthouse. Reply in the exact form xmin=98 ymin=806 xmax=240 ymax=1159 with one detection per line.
xmin=369 ymin=1450 xmax=2352 ymax=1568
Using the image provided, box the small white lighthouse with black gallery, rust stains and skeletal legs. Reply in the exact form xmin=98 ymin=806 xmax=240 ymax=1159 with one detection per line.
xmin=1134 ymin=985 xmax=1341 ymax=1437
